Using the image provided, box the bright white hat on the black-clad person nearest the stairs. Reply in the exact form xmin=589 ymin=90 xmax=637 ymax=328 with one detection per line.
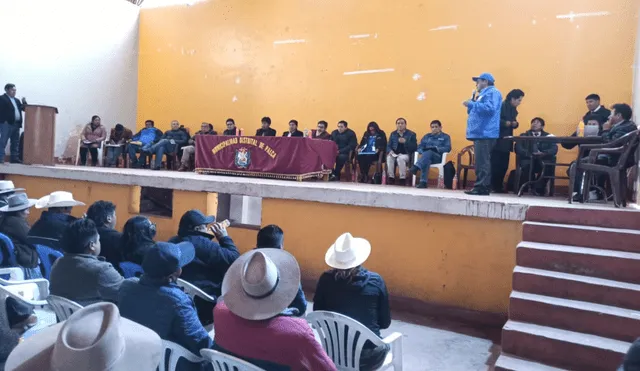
xmin=324 ymin=233 xmax=371 ymax=269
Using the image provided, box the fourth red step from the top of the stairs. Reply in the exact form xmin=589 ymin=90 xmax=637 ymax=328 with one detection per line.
xmin=513 ymin=266 xmax=640 ymax=310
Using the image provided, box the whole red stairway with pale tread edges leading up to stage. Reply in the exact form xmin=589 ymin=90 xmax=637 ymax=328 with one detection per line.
xmin=495 ymin=207 xmax=640 ymax=371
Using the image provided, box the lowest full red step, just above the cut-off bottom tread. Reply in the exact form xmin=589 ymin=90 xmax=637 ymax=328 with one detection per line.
xmin=502 ymin=320 xmax=631 ymax=371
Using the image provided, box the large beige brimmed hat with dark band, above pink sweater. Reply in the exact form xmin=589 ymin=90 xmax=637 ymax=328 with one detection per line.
xmin=222 ymin=249 xmax=300 ymax=321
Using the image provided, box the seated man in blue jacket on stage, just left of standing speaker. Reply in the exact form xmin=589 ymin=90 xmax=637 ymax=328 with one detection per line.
xmin=411 ymin=120 xmax=451 ymax=188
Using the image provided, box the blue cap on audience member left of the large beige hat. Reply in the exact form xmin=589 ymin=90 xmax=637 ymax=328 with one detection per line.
xmin=142 ymin=242 xmax=196 ymax=278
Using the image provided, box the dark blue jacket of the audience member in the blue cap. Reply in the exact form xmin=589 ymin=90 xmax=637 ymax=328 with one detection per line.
xmin=118 ymin=275 xmax=213 ymax=370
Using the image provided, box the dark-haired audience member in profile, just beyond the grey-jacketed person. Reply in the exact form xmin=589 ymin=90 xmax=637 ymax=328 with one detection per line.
xmin=87 ymin=201 xmax=122 ymax=267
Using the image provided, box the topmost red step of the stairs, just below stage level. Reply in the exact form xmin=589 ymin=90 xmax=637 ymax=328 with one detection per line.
xmin=525 ymin=206 xmax=640 ymax=230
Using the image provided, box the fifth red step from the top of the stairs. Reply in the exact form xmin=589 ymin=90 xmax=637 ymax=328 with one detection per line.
xmin=509 ymin=291 xmax=640 ymax=343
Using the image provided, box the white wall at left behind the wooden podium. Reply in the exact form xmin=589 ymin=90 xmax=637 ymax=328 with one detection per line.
xmin=0 ymin=0 xmax=139 ymax=157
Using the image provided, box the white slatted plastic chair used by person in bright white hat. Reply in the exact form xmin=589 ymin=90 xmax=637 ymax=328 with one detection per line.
xmin=306 ymin=310 xmax=402 ymax=371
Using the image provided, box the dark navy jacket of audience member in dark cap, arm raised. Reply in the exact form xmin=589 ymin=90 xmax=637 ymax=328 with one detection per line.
xmin=169 ymin=232 xmax=240 ymax=296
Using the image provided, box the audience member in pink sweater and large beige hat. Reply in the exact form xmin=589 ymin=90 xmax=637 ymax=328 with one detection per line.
xmin=213 ymin=249 xmax=336 ymax=371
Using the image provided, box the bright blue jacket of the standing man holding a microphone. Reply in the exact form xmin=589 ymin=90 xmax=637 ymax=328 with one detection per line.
xmin=467 ymin=86 xmax=502 ymax=140
